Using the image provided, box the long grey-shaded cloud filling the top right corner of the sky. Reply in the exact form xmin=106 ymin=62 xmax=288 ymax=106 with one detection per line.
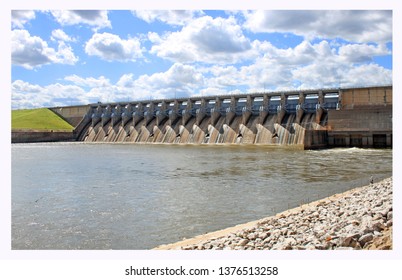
xmin=244 ymin=10 xmax=392 ymax=43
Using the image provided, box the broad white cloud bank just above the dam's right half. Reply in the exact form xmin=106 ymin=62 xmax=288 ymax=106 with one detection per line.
xmin=201 ymin=40 xmax=392 ymax=92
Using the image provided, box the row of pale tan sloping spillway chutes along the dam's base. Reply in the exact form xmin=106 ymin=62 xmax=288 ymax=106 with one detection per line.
xmin=78 ymin=107 xmax=326 ymax=146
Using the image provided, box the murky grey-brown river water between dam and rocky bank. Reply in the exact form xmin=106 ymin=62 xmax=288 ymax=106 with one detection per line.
xmin=12 ymin=143 xmax=392 ymax=249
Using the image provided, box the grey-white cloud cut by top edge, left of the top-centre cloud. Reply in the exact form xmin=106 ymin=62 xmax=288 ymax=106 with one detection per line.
xmin=51 ymin=10 xmax=112 ymax=30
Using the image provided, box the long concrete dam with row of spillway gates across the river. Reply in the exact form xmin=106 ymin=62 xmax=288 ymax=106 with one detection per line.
xmin=51 ymin=86 xmax=392 ymax=149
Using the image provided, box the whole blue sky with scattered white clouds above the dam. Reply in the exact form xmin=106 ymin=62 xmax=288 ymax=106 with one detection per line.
xmin=11 ymin=9 xmax=392 ymax=109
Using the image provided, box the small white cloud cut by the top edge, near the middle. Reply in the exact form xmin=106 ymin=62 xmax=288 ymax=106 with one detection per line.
xmin=132 ymin=10 xmax=203 ymax=25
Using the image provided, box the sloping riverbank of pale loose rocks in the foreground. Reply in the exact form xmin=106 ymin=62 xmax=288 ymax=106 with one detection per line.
xmin=155 ymin=178 xmax=393 ymax=250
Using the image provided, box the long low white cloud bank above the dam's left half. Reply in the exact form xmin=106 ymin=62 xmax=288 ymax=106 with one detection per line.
xmin=11 ymin=63 xmax=204 ymax=109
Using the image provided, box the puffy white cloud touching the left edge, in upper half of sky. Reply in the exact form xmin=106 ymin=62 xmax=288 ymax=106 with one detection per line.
xmin=11 ymin=30 xmax=78 ymax=69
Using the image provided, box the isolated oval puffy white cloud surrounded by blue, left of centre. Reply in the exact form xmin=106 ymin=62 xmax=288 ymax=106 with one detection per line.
xmin=85 ymin=33 xmax=143 ymax=62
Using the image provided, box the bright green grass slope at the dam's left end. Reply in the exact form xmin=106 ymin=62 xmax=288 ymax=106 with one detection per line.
xmin=11 ymin=108 xmax=74 ymax=131
